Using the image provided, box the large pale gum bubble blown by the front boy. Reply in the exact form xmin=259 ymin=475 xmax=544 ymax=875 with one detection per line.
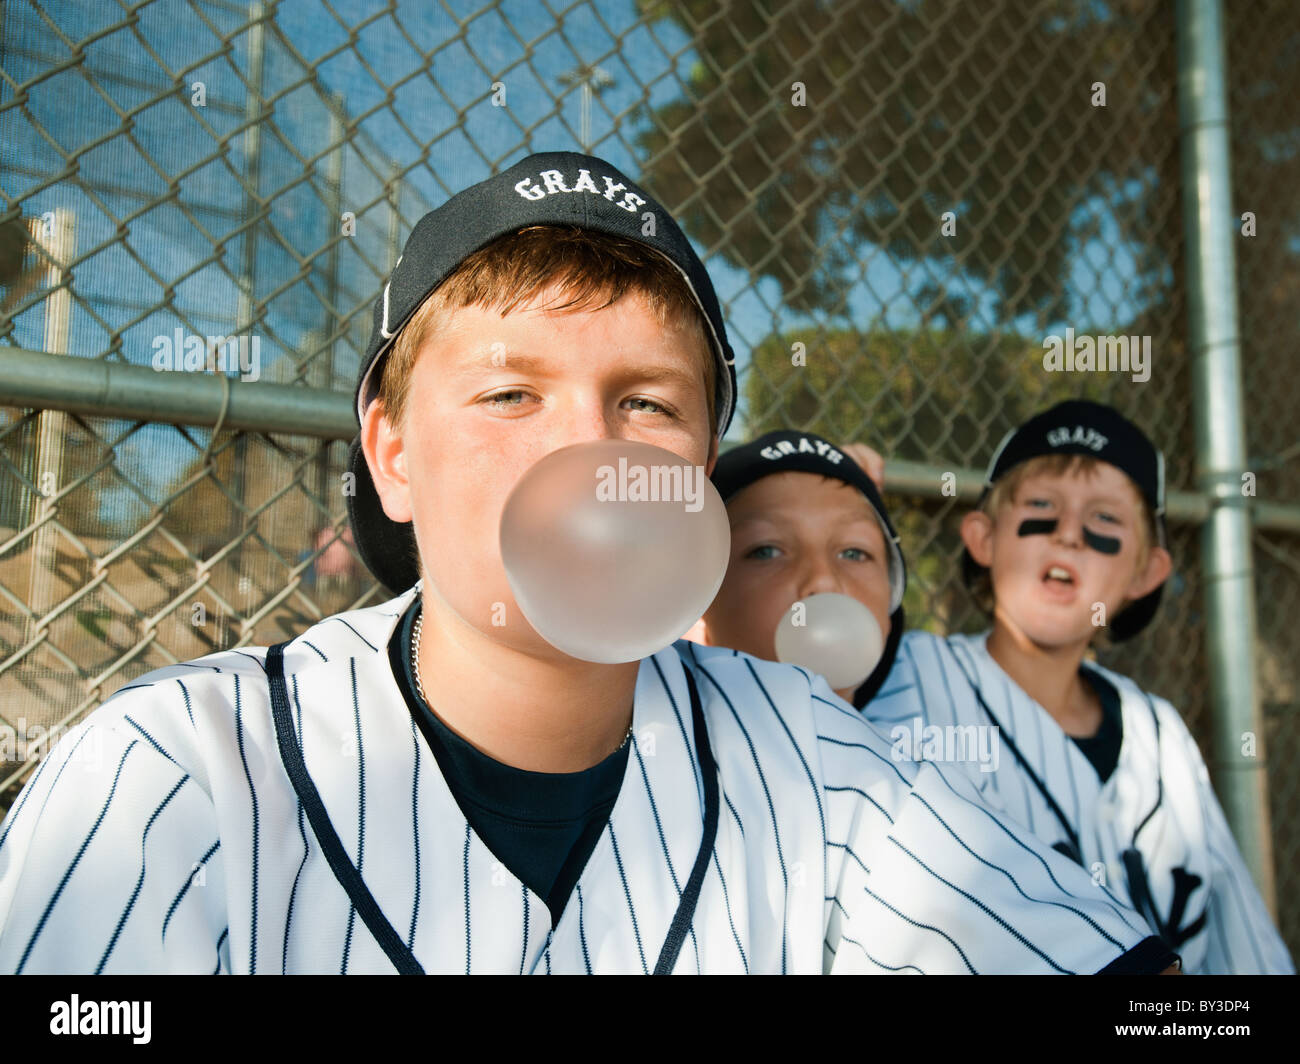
xmin=501 ymin=440 xmax=731 ymax=665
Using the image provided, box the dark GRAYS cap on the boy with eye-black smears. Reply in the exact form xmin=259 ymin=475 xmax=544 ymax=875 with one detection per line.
xmin=962 ymin=399 xmax=1169 ymax=643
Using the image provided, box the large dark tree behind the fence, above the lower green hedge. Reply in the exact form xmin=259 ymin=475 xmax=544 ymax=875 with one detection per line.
xmin=640 ymin=0 xmax=1177 ymax=321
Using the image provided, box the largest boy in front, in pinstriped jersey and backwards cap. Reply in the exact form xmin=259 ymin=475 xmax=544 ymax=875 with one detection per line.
xmin=0 ymin=152 xmax=1177 ymax=973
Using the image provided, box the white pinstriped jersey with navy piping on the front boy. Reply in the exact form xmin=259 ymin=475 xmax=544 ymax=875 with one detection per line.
xmin=0 ymin=589 xmax=1171 ymax=973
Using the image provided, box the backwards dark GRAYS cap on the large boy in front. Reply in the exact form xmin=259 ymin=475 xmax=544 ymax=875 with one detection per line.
xmin=348 ymin=152 xmax=736 ymax=593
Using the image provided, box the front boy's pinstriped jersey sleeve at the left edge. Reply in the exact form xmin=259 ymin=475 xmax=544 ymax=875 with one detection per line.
xmin=0 ymin=676 xmax=229 ymax=974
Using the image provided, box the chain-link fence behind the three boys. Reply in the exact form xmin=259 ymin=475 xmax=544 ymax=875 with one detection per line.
xmin=0 ymin=0 xmax=1300 ymax=952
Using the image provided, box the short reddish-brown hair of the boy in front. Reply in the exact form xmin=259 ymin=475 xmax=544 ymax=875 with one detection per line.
xmin=378 ymin=225 xmax=718 ymax=436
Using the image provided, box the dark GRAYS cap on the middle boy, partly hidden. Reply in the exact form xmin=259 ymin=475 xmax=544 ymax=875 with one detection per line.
xmin=711 ymin=429 xmax=907 ymax=709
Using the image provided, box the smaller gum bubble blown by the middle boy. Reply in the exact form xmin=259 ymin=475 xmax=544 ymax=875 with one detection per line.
xmin=776 ymin=592 xmax=885 ymax=691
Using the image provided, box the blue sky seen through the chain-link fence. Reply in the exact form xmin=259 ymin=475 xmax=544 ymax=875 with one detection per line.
xmin=0 ymin=0 xmax=1154 ymax=522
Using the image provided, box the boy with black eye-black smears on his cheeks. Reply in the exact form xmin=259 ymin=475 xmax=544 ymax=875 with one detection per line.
xmin=865 ymin=401 xmax=1294 ymax=973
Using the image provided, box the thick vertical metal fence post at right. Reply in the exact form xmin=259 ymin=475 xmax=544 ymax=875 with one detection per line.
xmin=1178 ymin=0 xmax=1277 ymax=913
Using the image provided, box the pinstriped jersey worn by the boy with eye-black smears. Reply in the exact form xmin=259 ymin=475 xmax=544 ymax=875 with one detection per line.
xmin=866 ymin=632 xmax=1295 ymax=974
